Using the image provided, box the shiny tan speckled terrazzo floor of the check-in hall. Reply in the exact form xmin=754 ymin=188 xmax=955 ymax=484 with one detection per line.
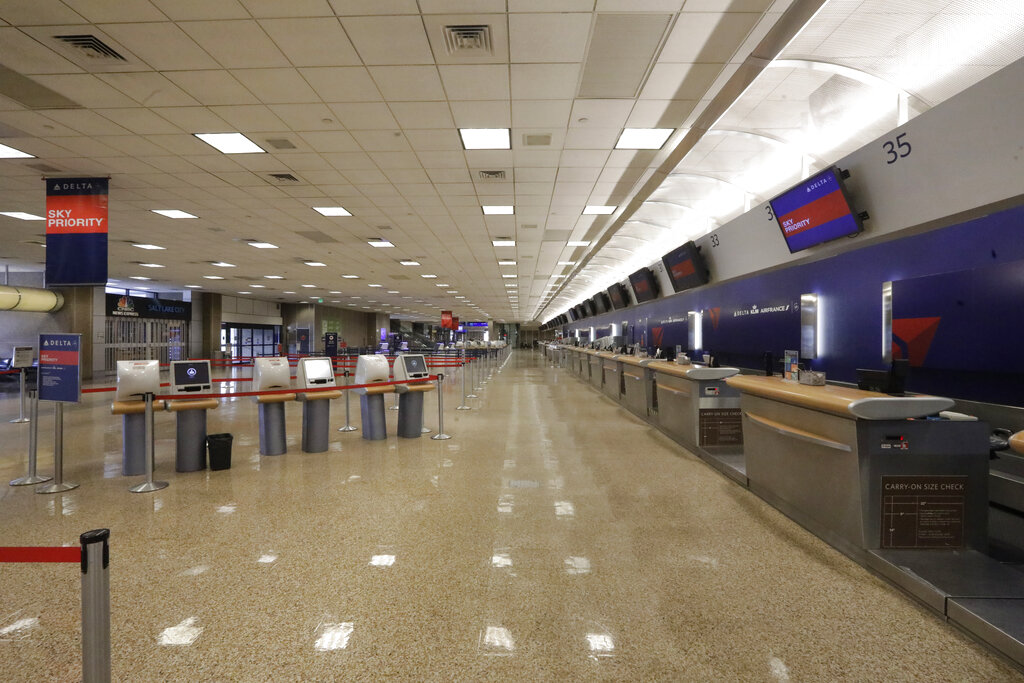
xmin=0 ymin=351 xmax=1024 ymax=681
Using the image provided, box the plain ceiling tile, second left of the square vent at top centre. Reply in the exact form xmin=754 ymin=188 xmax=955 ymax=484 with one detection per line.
xmin=259 ymin=17 xmax=361 ymax=67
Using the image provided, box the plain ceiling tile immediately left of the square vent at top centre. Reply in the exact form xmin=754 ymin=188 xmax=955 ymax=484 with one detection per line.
xmin=341 ymin=16 xmax=434 ymax=67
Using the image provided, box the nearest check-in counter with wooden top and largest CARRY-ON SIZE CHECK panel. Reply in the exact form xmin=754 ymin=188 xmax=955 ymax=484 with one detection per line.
xmin=726 ymin=375 xmax=988 ymax=561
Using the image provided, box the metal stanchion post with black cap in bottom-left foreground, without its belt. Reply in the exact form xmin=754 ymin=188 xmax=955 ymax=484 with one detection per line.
xmin=79 ymin=528 xmax=111 ymax=683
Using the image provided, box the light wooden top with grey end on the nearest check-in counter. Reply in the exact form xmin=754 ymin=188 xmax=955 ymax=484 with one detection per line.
xmin=725 ymin=375 xmax=953 ymax=420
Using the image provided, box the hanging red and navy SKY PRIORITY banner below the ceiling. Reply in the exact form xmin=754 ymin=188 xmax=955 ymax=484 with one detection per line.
xmin=46 ymin=178 xmax=109 ymax=287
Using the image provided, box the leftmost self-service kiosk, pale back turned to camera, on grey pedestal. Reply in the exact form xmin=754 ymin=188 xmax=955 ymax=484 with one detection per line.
xmin=111 ymin=360 xmax=163 ymax=476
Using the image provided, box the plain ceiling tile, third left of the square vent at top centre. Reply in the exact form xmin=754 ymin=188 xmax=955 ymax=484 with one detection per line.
xmin=180 ymin=19 xmax=289 ymax=69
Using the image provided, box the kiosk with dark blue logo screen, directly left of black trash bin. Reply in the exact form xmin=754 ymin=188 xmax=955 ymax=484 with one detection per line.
xmin=167 ymin=360 xmax=220 ymax=472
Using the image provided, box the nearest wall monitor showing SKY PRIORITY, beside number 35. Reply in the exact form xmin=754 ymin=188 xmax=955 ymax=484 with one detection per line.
xmin=769 ymin=166 xmax=863 ymax=254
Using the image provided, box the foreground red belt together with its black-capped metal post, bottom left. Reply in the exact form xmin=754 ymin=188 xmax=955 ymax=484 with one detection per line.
xmin=0 ymin=528 xmax=111 ymax=683
